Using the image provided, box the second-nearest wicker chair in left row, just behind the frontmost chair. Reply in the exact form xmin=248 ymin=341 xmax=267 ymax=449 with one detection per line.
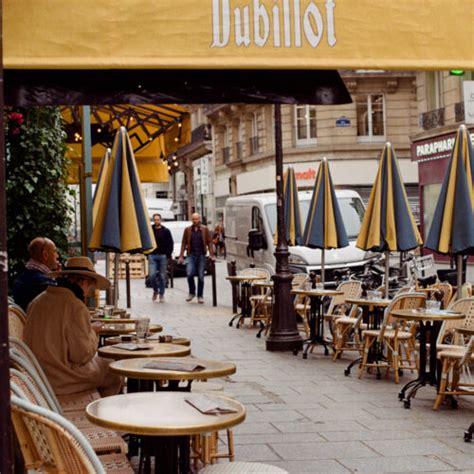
xmin=10 ymin=349 xmax=128 ymax=454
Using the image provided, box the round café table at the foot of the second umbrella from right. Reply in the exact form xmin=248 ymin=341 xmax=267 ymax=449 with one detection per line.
xmin=344 ymin=298 xmax=390 ymax=379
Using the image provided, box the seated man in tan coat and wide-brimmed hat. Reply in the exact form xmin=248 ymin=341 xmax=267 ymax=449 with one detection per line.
xmin=24 ymin=257 xmax=121 ymax=396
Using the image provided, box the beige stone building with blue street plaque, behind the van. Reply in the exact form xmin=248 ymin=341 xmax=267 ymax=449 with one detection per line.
xmin=171 ymin=71 xmax=418 ymax=225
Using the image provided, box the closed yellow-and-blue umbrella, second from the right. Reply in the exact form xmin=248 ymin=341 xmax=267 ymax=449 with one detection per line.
xmin=356 ymin=142 xmax=423 ymax=296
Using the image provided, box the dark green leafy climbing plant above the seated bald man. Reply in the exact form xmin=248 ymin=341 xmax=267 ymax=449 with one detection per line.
xmin=5 ymin=107 xmax=71 ymax=283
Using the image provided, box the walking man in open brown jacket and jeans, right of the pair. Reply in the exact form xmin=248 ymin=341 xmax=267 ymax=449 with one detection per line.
xmin=178 ymin=213 xmax=214 ymax=304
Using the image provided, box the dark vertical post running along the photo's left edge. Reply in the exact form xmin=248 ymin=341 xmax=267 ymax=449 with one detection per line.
xmin=0 ymin=1 xmax=13 ymax=473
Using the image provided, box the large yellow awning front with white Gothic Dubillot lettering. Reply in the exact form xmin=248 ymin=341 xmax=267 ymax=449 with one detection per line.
xmin=3 ymin=0 xmax=474 ymax=70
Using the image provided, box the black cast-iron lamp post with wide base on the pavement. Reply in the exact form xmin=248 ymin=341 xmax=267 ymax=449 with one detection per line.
xmin=266 ymin=104 xmax=303 ymax=352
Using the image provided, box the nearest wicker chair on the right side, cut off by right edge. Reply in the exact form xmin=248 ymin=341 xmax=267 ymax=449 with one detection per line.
xmin=433 ymin=336 xmax=474 ymax=410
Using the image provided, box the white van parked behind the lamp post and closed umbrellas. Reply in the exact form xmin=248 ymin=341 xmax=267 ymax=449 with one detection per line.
xmin=225 ymin=190 xmax=370 ymax=283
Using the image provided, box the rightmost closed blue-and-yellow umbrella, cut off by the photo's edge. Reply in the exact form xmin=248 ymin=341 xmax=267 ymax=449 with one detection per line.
xmin=425 ymin=125 xmax=474 ymax=298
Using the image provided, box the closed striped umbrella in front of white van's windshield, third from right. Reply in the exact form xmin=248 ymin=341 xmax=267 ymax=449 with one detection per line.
xmin=303 ymin=158 xmax=349 ymax=284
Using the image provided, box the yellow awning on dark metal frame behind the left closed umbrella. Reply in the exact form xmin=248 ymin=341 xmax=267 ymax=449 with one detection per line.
xmin=62 ymin=104 xmax=191 ymax=184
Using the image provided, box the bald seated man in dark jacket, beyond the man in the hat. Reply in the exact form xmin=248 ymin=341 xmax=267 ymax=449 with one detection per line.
xmin=13 ymin=237 xmax=59 ymax=311
